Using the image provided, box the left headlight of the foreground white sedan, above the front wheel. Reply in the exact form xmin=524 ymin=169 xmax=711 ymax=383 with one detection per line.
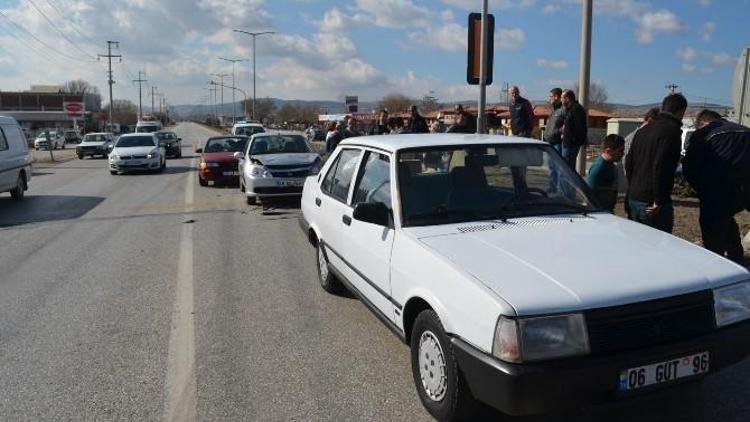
xmin=492 ymin=314 xmax=589 ymax=363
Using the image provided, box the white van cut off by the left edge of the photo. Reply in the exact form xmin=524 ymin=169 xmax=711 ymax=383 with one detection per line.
xmin=0 ymin=116 xmax=31 ymax=201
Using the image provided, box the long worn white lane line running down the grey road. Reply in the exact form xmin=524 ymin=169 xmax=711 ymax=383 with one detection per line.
xmin=163 ymin=159 xmax=197 ymax=422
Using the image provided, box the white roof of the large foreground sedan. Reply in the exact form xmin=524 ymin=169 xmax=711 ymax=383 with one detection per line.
xmin=339 ymin=133 xmax=546 ymax=152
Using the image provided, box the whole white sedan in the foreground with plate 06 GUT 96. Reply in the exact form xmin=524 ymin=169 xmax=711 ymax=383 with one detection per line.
xmin=300 ymin=134 xmax=750 ymax=420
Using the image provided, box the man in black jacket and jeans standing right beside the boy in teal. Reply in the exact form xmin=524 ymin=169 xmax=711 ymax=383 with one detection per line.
xmin=625 ymin=94 xmax=687 ymax=233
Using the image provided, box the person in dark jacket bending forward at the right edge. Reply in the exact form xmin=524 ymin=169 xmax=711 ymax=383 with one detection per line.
xmin=682 ymin=110 xmax=750 ymax=265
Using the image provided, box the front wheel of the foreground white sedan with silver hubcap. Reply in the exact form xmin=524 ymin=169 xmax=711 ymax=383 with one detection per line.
xmin=410 ymin=309 xmax=476 ymax=421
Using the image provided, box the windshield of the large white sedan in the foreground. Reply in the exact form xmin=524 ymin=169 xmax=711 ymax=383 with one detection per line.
xmin=398 ymin=144 xmax=598 ymax=226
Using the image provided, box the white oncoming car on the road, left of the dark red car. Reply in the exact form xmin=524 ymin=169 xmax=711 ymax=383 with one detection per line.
xmin=109 ymin=133 xmax=167 ymax=175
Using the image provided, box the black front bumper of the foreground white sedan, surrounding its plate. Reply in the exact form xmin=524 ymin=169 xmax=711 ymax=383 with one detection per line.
xmin=451 ymin=321 xmax=750 ymax=415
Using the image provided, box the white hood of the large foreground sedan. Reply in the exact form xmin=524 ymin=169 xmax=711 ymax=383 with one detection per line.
xmin=412 ymin=214 xmax=750 ymax=316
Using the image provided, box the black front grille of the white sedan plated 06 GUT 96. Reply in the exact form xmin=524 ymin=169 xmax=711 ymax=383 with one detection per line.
xmin=585 ymin=290 xmax=716 ymax=355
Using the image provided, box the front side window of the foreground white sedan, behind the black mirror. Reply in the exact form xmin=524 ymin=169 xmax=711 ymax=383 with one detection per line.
xmin=352 ymin=151 xmax=392 ymax=209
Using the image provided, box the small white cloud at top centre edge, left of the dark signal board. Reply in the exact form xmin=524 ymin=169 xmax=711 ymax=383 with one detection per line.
xmin=356 ymin=0 xmax=433 ymax=28
